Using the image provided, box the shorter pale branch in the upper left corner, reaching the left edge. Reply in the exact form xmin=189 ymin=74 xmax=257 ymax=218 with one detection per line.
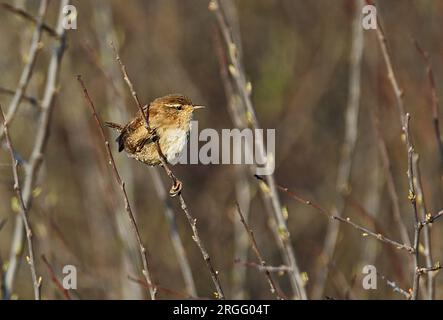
xmin=0 ymin=0 xmax=48 ymax=141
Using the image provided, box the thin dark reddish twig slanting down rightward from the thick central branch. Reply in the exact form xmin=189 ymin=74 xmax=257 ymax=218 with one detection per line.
xmin=256 ymin=176 xmax=415 ymax=253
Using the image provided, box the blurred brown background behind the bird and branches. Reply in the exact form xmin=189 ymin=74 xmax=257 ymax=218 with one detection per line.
xmin=0 ymin=0 xmax=443 ymax=299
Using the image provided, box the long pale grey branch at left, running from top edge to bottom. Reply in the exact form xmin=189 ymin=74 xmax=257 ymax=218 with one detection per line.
xmin=5 ymin=0 xmax=69 ymax=298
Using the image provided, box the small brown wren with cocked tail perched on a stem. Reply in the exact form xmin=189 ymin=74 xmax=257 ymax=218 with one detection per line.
xmin=106 ymin=94 xmax=203 ymax=166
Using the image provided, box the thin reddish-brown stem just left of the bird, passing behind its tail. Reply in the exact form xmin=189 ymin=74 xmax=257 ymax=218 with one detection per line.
xmin=77 ymin=76 xmax=157 ymax=300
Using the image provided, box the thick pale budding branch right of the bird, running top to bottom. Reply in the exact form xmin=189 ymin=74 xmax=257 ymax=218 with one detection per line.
xmin=209 ymin=0 xmax=307 ymax=300
